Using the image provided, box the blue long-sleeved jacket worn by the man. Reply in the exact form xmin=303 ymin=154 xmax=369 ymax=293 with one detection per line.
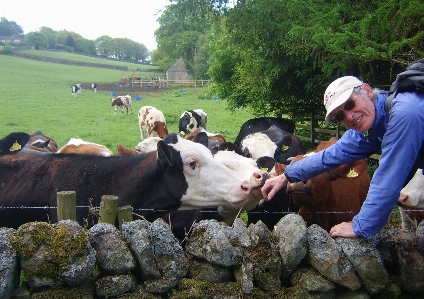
xmin=285 ymin=92 xmax=424 ymax=238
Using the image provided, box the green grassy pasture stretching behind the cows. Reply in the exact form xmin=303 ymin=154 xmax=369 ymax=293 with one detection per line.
xmin=0 ymin=51 xmax=253 ymax=153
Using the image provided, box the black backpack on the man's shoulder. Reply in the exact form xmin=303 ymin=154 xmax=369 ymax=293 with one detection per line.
xmin=384 ymin=59 xmax=424 ymax=114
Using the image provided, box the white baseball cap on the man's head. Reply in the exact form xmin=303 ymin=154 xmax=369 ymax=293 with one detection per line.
xmin=324 ymin=76 xmax=363 ymax=125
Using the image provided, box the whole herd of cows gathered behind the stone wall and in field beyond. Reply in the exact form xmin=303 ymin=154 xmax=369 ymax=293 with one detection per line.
xmin=0 ymin=102 xmax=424 ymax=239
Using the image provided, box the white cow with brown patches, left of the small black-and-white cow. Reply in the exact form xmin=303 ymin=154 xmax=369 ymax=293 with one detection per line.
xmin=138 ymin=106 xmax=168 ymax=141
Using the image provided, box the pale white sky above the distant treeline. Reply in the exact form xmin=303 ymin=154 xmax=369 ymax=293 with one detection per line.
xmin=0 ymin=0 xmax=170 ymax=51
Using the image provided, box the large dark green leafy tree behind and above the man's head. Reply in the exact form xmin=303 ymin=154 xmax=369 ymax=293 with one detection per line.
xmin=208 ymin=0 xmax=424 ymax=119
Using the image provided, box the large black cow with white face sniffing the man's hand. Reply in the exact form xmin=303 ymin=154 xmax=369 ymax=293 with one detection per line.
xmin=0 ymin=133 xmax=257 ymax=228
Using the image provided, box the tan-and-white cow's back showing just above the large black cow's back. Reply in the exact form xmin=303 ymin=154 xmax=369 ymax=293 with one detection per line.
xmin=57 ymin=138 xmax=114 ymax=157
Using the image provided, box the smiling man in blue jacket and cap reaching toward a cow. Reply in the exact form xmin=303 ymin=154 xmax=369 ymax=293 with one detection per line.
xmin=262 ymin=76 xmax=424 ymax=238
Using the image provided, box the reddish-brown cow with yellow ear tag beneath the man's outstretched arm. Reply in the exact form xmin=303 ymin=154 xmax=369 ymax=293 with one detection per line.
xmin=287 ymin=138 xmax=371 ymax=231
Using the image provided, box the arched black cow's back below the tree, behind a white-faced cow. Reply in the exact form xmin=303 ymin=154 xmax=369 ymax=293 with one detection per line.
xmin=234 ymin=117 xmax=295 ymax=146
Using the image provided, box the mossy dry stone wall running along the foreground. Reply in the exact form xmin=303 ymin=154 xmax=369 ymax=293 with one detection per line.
xmin=0 ymin=214 xmax=424 ymax=299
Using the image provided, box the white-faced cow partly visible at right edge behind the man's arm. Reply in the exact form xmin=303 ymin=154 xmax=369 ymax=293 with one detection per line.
xmin=398 ymin=168 xmax=424 ymax=230
